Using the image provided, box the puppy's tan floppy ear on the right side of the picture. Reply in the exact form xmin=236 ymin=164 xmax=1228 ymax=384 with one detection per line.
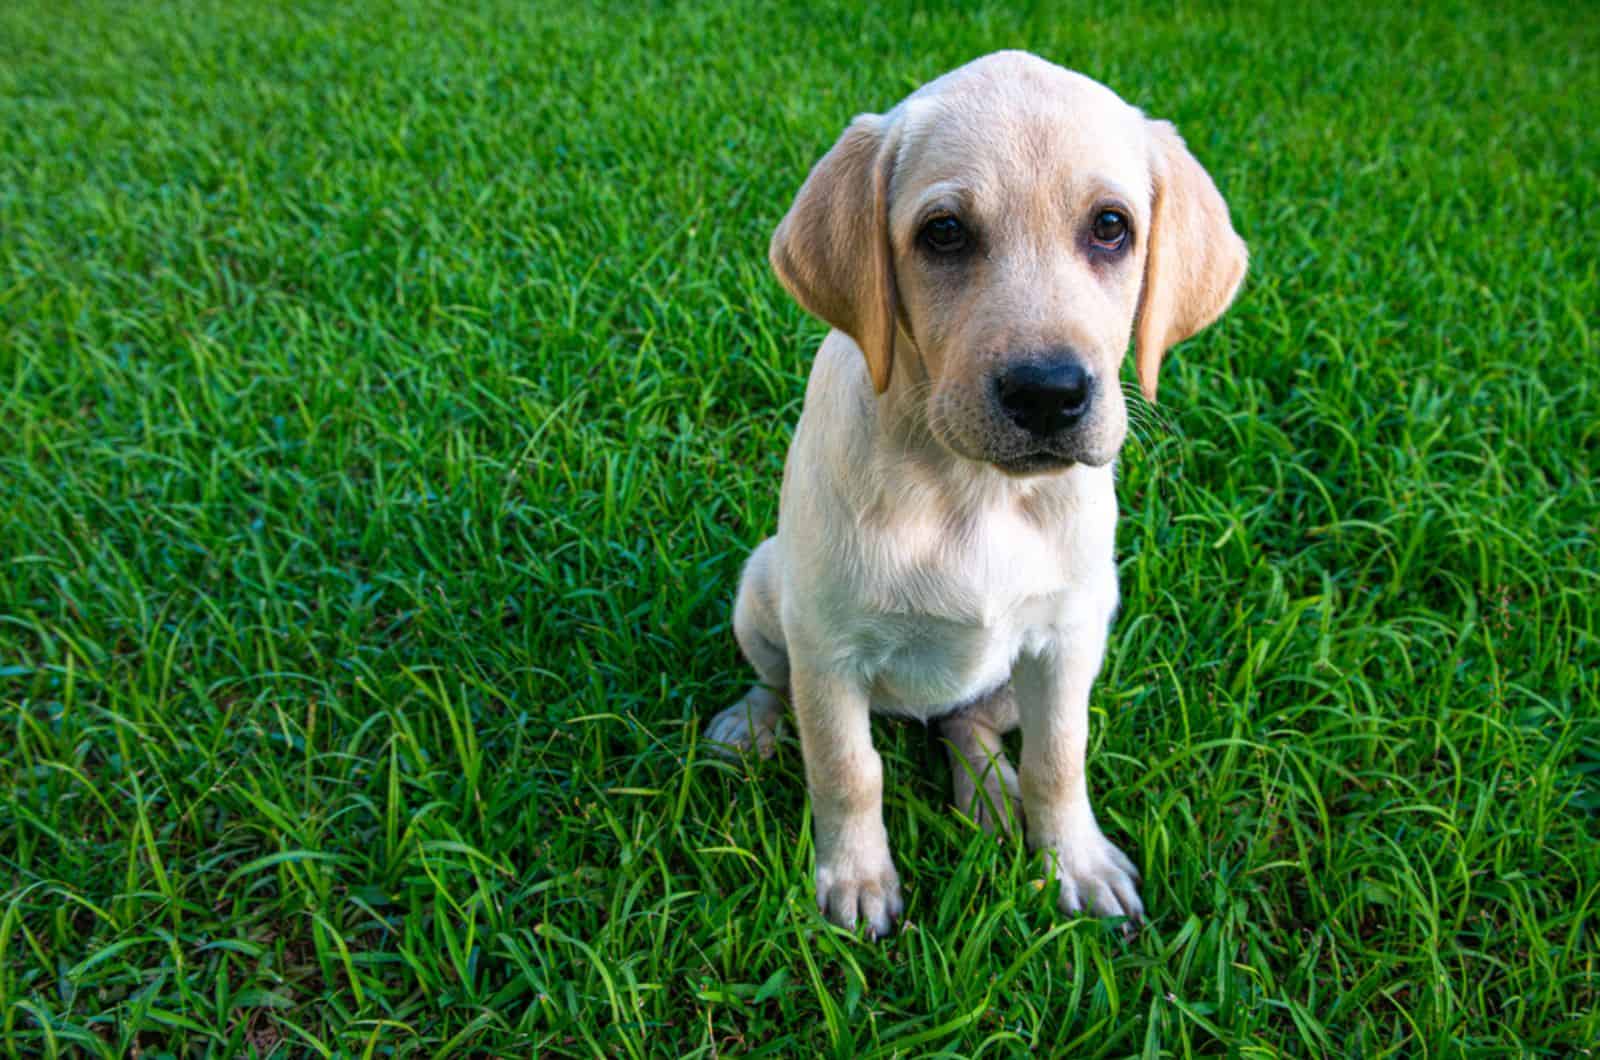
xmin=1134 ymin=122 xmax=1250 ymax=402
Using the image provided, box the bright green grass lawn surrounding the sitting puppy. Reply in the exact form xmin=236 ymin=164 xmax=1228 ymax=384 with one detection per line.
xmin=0 ymin=0 xmax=1600 ymax=1057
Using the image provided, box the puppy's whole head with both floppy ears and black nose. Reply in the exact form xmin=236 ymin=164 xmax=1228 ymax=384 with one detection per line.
xmin=771 ymin=53 xmax=1246 ymax=474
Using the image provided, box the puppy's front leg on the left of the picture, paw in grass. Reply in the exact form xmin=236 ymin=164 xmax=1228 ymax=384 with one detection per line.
xmin=790 ymin=665 xmax=902 ymax=938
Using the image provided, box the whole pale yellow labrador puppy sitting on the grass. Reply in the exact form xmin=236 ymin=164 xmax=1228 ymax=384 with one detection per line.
xmin=706 ymin=51 xmax=1246 ymax=935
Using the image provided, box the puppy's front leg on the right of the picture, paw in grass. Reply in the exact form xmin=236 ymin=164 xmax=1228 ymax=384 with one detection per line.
xmin=1011 ymin=626 xmax=1144 ymax=924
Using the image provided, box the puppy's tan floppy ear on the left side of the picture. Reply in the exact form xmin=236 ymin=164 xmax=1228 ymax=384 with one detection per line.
xmin=766 ymin=114 xmax=899 ymax=394
